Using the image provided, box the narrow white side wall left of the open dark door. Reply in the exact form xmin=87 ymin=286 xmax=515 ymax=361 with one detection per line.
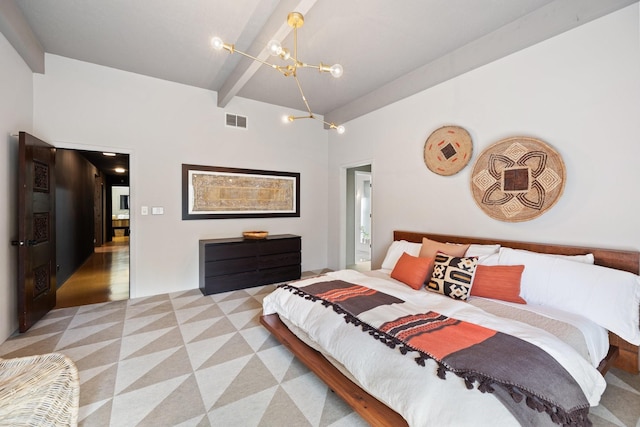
xmin=0 ymin=34 xmax=33 ymax=341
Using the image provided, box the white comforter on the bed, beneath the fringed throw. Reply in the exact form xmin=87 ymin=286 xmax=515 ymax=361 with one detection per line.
xmin=263 ymin=270 xmax=606 ymax=426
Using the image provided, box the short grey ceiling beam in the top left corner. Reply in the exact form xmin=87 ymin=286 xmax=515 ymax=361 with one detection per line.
xmin=0 ymin=0 xmax=44 ymax=73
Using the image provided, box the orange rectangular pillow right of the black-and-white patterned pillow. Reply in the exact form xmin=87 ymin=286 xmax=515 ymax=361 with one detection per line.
xmin=471 ymin=265 xmax=527 ymax=304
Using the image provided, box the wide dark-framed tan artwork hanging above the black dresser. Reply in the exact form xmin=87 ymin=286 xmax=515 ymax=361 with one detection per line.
xmin=182 ymin=164 xmax=300 ymax=220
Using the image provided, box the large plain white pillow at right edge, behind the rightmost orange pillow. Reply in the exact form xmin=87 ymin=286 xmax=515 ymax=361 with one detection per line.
xmin=499 ymin=248 xmax=640 ymax=345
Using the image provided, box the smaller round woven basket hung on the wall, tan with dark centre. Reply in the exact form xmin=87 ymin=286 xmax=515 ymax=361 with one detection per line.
xmin=424 ymin=126 xmax=473 ymax=176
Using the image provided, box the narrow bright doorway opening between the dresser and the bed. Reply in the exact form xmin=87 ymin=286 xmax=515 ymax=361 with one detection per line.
xmin=345 ymin=165 xmax=372 ymax=271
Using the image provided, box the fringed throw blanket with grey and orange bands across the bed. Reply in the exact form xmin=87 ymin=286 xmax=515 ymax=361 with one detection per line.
xmin=282 ymin=280 xmax=591 ymax=426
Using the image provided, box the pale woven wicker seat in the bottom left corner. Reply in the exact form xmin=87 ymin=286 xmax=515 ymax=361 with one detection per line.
xmin=0 ymin=353 xmax=80 ymax=426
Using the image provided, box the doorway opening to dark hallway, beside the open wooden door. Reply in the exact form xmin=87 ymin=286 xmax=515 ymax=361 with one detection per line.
xmin=56 ymin=148 xmax=130 ymax=308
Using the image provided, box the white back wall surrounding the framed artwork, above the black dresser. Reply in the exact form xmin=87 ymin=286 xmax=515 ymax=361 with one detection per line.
xmin=34 ymin=55 xmax=328 ymax=297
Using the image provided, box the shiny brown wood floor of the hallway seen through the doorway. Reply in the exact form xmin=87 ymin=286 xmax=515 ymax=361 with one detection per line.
xmin=55 ymin=236 xmax=129 ymax=308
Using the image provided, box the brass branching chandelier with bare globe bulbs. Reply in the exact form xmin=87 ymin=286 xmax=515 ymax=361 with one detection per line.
xmin=211 ymin=12 xmax=345 ymax=134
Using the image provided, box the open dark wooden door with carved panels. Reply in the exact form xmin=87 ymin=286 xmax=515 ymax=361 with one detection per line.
xmin=16 ymin=132 xmax=56 ymax=332
